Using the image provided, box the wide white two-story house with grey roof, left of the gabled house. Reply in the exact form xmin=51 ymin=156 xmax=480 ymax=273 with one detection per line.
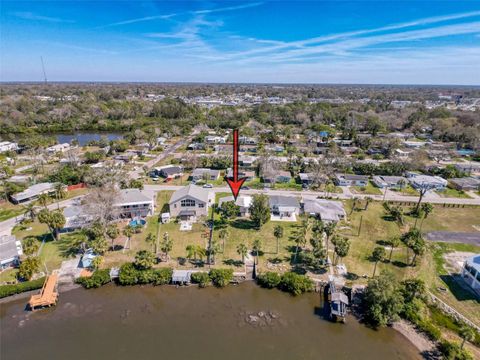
xmin=115 ymin=189 xmax=155 ymax=218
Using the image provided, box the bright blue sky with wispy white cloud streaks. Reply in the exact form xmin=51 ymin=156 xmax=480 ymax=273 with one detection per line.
xmin=0 ymin=0 xmax=480 ymax=85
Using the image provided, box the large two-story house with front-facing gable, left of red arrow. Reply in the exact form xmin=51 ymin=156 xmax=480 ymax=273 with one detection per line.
xmin=169 ymin=184 xmax=215 ymax=221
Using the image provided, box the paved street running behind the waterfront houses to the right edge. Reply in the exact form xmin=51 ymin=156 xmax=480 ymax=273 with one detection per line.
xmin=145 ymin=185 xmax=480 ymax=205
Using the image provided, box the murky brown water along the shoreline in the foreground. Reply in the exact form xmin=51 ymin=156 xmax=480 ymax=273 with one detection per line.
xmin=0 ymin=283 xmax=420 ymax=360
